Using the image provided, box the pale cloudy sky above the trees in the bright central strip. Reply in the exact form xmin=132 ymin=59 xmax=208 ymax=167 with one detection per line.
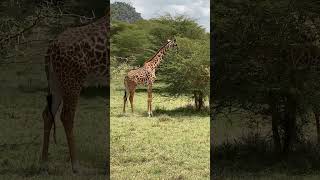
xmin=111 ymin=0 xmax=210 ymax=32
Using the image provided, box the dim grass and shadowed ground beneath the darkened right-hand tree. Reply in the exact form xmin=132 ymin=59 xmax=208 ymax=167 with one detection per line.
xmin=211 ymin=111 xmax=320 ymax=180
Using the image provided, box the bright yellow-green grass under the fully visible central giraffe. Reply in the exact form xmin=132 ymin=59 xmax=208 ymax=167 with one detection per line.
xmin=110 ymin=76 xmax=210 ymax=179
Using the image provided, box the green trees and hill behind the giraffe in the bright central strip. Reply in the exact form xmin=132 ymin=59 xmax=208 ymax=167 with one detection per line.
xmin=111 ymin=2 xmax=210 ymax=106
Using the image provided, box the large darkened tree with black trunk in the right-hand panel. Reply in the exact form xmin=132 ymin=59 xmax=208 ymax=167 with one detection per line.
xmin=212 ymin=0 xmax=320 ymax=154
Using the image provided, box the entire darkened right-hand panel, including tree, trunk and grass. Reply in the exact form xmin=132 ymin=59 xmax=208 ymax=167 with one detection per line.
xmin=211 ymin=0 xmax=320 ymax=179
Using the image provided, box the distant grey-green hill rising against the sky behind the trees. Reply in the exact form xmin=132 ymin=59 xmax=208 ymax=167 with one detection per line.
xmin=110 ymin=2 xmax=142 ymax=23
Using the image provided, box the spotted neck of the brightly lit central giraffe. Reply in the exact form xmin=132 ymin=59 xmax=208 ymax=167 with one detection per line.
xmin=143 ymin=42 xmax=170 ymax=70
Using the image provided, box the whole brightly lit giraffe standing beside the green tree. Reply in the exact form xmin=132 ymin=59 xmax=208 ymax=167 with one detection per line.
xmin=123 ymin=39 xmax=178 ymax=117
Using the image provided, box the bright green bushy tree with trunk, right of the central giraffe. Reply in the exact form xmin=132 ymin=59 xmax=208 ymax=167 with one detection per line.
xmin=161 ymin=38 xmax=210 ymax=110
